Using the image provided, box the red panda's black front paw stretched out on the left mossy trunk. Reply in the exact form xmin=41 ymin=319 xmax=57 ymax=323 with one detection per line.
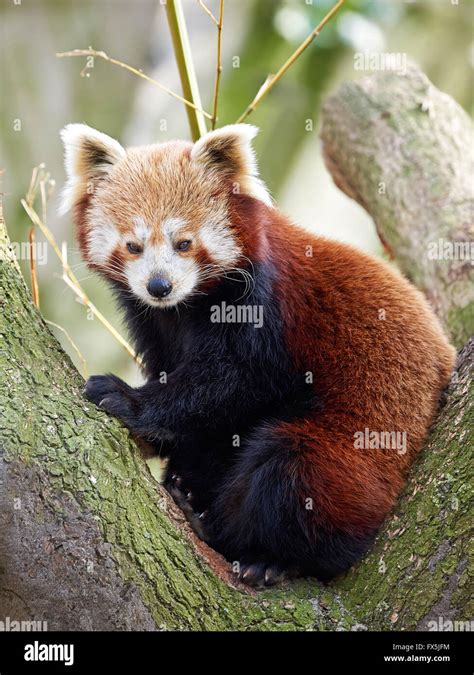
xmin=84 ymin=375 xmax=139 ymax=426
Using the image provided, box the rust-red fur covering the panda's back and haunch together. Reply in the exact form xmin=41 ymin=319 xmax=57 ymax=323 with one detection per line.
xmin=229 ymin=197 xmax=455 ymax=534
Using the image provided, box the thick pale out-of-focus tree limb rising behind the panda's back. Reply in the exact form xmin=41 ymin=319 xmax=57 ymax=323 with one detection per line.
xmin=321 ymin=64 xmax=474 ymax=347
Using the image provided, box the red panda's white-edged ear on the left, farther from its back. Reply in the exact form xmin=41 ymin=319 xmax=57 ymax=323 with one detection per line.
xmin=59 ymin=124 xmax=125 ymax=214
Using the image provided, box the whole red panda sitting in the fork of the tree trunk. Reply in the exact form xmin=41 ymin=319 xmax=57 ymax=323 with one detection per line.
xmin=62 ymin=124 xmax=455 ymax=585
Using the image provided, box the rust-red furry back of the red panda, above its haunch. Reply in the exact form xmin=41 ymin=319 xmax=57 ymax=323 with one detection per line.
xmin=269 ymin=214 xmax=455 ymax=460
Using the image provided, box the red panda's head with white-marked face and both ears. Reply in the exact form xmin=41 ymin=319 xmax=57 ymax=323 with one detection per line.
xmin=61 ymin=124 xmax=270 ymax=307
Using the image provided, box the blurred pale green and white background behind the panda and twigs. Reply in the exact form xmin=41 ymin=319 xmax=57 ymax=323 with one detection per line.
xmin=0 ymin=0 xmax=474 ymax=384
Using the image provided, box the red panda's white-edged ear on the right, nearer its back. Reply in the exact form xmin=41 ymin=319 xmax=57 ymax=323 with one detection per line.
xmin=191 ymin=124 xmax=271 ymax=206
